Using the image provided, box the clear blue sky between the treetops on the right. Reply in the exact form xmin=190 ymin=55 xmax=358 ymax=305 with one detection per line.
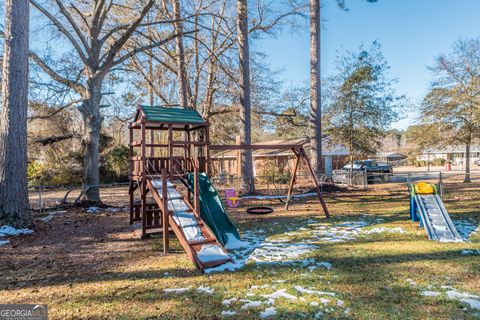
xmin=255 ymin=0 xmax=480 ymax=129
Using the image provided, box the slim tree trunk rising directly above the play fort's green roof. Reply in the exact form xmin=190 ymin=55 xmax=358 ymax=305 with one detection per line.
xmin=172 ymin=0 xmax=189 ymax=108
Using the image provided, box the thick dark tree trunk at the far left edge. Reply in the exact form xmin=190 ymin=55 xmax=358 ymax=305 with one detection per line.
xmin=0 ymin=0 xmax=32 ymax=228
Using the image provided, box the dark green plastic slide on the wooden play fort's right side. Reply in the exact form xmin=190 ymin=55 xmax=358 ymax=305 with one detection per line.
xmin=187 ymin=173 xmax=240 ymax=246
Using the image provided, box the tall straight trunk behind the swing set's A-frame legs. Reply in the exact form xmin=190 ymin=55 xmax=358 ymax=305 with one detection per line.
xmin=310 ymin=0 xmax=322 ymax=175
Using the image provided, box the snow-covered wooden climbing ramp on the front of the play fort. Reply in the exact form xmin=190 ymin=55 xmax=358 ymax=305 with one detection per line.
xmin=147 ymin=178 xmax=232 ymax=270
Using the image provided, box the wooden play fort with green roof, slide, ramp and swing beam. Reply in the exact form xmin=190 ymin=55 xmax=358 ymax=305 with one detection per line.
xmin=129 ymin=106 xmax=329 ymax=270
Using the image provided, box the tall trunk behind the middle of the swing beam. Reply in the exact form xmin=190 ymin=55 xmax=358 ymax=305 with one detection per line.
xmin=237 ymin=0 xmax=255 ymax=193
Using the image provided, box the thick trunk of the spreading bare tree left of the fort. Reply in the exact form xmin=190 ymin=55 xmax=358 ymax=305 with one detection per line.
xmin=82 ymin=78 xmax=103 ymax=203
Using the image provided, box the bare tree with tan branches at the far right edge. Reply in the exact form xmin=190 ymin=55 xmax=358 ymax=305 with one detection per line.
xmin=421 ymin=38 xmax=480 ymax=182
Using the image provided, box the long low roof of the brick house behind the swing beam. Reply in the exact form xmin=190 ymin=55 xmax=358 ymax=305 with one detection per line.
xmin=212 ymin=137 xmax=348 ymax=159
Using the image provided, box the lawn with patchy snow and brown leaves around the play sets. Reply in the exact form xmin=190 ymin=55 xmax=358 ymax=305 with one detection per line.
xmin=0 ymin=192 xmax=480 ymax=319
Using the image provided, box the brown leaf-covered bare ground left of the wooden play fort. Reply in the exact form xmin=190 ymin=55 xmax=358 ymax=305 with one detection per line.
xmin=0 ymin=208 xmax=152 ymax=290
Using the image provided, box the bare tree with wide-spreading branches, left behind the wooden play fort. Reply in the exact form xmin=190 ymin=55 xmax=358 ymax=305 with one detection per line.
xmin=30 ymin=0 xmax=186 ymax=202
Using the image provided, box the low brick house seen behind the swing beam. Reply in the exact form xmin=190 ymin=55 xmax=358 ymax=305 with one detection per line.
xmin=211 ymin=138 xmax=349 ymax=176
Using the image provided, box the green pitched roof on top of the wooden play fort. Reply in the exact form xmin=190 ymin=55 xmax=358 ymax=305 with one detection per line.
xmin=137 ymin=106 xmax=207 ymax=124
